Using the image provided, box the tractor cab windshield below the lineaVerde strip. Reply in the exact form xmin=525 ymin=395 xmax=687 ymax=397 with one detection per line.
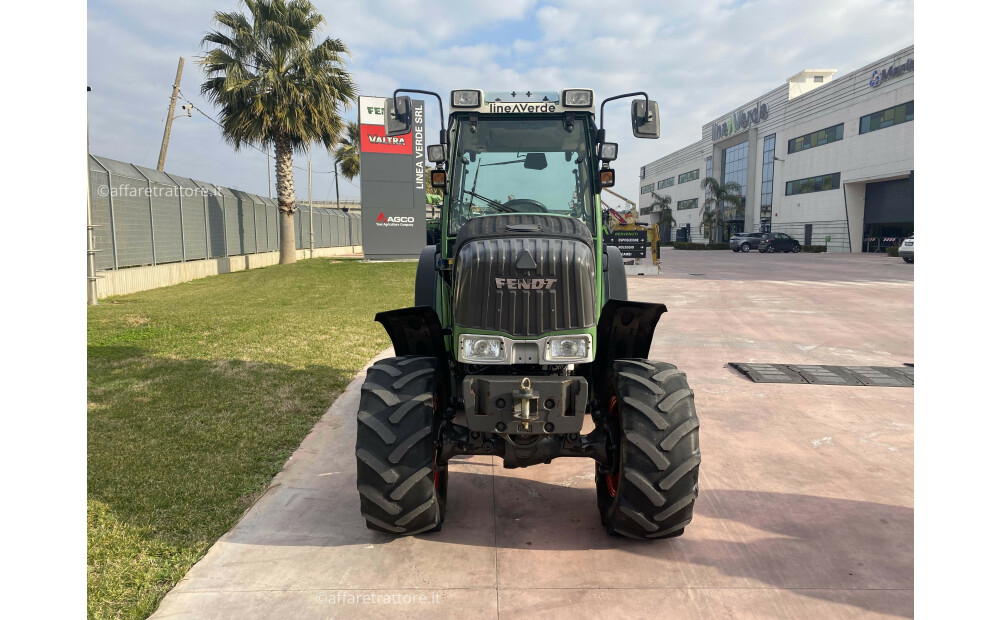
xmin=449 ymin=118 xmax=594 ymax=234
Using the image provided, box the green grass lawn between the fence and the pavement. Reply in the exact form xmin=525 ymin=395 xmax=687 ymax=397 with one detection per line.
xmin=87 ymin=259 xmax=416 ymax=618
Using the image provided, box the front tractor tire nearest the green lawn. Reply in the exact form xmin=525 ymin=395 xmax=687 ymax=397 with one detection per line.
xmin=355 ymin=355 xmax=448 ymax=536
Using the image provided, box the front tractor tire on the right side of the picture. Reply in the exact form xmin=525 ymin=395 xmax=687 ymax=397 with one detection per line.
xmin=596 ymin=359 xmax=701 ymax=539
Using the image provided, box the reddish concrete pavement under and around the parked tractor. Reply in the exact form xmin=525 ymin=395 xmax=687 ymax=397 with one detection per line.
xmin=155 ymin=251 xmax=913 ymax=618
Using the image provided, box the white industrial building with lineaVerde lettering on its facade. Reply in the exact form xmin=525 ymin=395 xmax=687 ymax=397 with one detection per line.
xmin=639 ymin=46 xmax=913 ymax=252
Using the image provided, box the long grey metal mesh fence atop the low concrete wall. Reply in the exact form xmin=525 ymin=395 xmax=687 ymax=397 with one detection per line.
xmin=90 ymin=155 xmax=361 ymax=270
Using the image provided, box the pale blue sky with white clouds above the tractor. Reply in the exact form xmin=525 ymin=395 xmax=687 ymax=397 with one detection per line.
xmin=87 ymin=0 xmax=914 ymax=208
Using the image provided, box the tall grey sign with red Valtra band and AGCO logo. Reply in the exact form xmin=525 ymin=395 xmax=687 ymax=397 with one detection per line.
xmin=358 ymin=97 xmax=427 ymax=258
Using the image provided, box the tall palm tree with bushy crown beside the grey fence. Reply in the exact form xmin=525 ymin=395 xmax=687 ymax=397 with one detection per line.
xmin=198 ymin=0 xmax=356 ymax=264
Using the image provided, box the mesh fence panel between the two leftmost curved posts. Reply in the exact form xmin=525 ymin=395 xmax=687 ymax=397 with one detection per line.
xmin=94 ymin=156 xmax=153 ymax=267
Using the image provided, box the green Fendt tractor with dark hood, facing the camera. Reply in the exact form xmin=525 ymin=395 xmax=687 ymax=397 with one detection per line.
xmin=356 ymin=89 xmax=701 ymax=539
